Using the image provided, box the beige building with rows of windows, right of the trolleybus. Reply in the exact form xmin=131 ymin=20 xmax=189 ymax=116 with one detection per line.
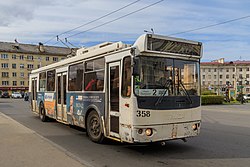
xmin=201 ymin=58 xmax=250 ymax=96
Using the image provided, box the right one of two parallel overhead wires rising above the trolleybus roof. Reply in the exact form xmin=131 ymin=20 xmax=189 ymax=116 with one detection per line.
xmin=66 ymin=0 xmax=164 ymax=38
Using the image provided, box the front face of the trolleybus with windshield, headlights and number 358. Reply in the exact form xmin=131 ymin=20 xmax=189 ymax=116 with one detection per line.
xmin=127 ymin=34 xmax=202 ymax=142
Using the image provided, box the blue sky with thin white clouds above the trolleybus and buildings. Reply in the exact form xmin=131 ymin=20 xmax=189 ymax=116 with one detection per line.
xmin=0 ymin=0 xmax=250 ymax=61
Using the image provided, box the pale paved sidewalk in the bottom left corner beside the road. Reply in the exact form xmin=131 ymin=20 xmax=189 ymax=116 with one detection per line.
xmin=0 ymin=112 xmax=88 ymax=167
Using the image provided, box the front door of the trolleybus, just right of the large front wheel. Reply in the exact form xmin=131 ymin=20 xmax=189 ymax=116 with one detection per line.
xmin=108 ymin=62 xmax=120 ymax=138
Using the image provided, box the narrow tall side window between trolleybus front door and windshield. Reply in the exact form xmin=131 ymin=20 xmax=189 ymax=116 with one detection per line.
xmin=122 ymin=57 xmax=131 ymax=97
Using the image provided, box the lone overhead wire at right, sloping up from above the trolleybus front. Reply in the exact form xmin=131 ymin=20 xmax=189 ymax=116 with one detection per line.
xmin=169 ymin=15 xmax=250 ymax=36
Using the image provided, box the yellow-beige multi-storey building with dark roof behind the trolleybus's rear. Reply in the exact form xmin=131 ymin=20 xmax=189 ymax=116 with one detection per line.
xmin=0 ymin=42 xmax=71 ymax=94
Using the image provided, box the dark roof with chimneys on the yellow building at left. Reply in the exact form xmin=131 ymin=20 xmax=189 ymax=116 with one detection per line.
xmin=0 ymin=42 xmax=72 ymax=56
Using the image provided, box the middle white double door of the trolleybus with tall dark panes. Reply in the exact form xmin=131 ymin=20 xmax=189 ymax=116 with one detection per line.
xmin=56 ymin=73 xmax=67 ymax=122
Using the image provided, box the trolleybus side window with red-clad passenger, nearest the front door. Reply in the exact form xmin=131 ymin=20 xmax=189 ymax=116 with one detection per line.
xmin=84 ymin=58 xmax=105 ymax=91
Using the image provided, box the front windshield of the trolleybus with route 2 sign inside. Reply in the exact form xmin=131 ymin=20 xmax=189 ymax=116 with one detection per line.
xmin=134 ymin=56 xmax=200 ymax=98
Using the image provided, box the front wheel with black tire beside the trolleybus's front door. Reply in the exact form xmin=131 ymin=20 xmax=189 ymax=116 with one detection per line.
xmin=87 ymin=111 xmax=104 ymax=143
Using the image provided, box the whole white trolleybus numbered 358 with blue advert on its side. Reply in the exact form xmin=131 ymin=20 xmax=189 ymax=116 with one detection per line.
xmin=29 ymin=34 xmax=202 ymax=143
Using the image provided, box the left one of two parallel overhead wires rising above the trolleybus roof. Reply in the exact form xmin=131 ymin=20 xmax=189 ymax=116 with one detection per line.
xmin=44 ymin=0 xmax=141 ymax=44
